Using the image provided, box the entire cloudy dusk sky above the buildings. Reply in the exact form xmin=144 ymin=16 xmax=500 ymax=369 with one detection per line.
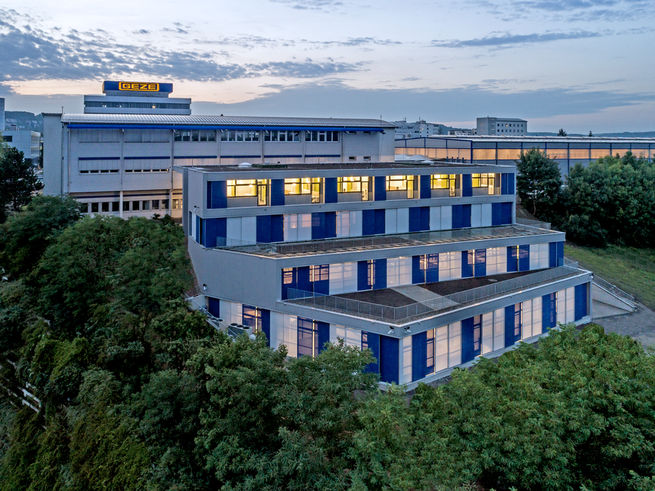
xmin=0 ymin=0 xmax=655 ymax=133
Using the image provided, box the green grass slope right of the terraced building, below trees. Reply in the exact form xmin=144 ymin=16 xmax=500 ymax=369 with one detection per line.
xmin=564 ymin=243 xmax=655 ymax=309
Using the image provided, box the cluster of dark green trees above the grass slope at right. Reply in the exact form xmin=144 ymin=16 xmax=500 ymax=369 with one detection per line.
xmin=517 ymin=149 xmax=655 ymax=247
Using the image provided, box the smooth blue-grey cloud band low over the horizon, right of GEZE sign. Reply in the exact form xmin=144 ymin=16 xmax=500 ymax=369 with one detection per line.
xmin=193 ymin=81 xmax=653 ymax=125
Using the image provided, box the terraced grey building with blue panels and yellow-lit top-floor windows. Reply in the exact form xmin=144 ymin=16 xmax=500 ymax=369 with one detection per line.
xmin=184 ymin=162 xmax=591 ymax=387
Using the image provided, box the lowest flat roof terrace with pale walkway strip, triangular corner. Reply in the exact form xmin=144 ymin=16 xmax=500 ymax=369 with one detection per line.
xmin=284 ymin=266 xmax=591 ymax=325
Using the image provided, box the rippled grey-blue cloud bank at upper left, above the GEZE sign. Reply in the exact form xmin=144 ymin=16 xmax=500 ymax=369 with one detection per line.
xmin=0 ymin=9 xmax=362 ymax=82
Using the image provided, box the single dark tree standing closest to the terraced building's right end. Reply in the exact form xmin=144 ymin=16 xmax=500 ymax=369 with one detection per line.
xmin=516 ymin=148 xmax=562 ymax=220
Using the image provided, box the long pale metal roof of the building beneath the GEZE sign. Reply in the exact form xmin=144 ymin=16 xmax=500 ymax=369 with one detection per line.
xmin=61 ymin=114 xmax=395 ymax=128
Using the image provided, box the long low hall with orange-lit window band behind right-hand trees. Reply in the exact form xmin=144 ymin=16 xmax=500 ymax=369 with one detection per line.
xmin=396 ymin=136 xmax=655 ymax=175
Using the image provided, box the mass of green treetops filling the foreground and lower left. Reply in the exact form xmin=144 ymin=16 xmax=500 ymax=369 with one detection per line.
xmin=0 ymin=198 xmax=655 ymax=490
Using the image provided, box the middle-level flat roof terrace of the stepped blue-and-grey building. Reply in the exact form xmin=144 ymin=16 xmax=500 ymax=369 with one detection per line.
xmin=217 ymin=225 xmax=562 ymax=258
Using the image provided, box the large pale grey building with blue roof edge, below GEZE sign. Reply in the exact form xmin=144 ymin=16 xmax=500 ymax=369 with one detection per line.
xmin=44 ymin=114 xmax=394 ymax=218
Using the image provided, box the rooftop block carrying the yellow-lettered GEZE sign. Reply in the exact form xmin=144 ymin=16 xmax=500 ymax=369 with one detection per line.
xmin=84 ymin=80 xmax=191 ymax=115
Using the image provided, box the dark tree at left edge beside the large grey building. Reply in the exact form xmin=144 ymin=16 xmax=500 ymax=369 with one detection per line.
xmin=0 ymin=147 xmax=43 ymax=223
